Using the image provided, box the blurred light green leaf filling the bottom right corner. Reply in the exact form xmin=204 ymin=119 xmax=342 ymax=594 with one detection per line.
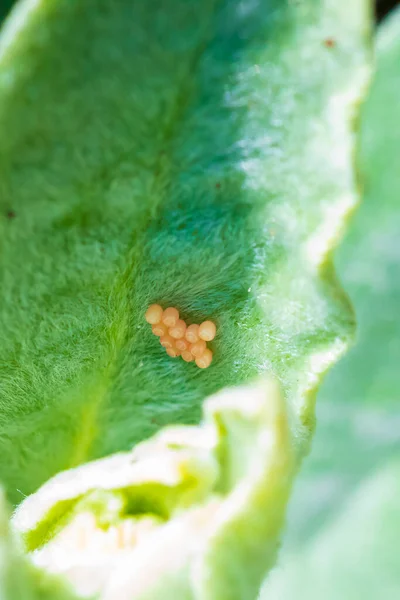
xmin=262 ymin=461 xmax=400 ymax=600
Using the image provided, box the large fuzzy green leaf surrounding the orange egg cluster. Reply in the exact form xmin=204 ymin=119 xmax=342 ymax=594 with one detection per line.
xmin=0 ymin=0 xmax=369 ymax=502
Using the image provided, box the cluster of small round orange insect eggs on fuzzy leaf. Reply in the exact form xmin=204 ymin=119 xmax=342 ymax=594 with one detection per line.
xmin=145 ymin=304 xmax=217 ymax=369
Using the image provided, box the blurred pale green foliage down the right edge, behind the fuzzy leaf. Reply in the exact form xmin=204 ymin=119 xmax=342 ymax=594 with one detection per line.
xmin=262 ymin=5 xmax=400 ymax=600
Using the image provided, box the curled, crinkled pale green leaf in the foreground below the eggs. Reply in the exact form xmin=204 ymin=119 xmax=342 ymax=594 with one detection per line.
xmin=13 ymin=382 xmax=295 ymax=600
